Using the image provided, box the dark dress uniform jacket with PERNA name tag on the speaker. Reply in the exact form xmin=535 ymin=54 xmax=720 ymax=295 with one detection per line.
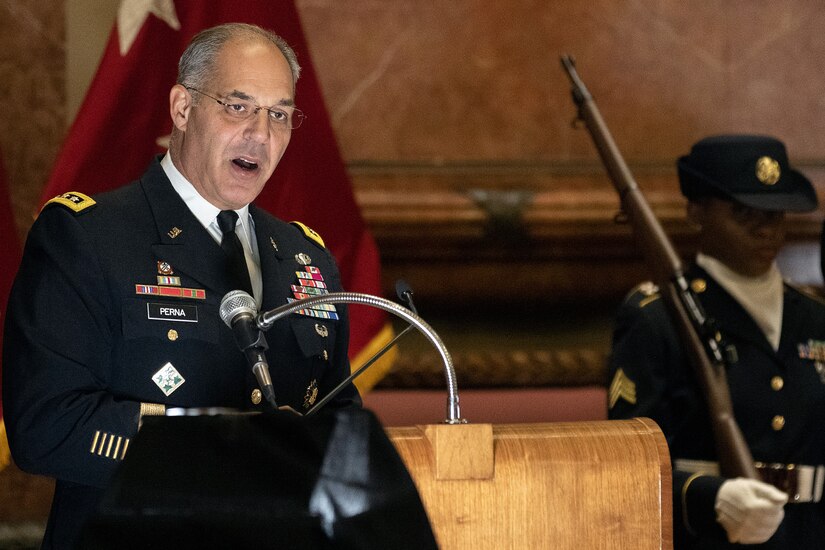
xmin=3 ymin=160 xmax=360 ymax=547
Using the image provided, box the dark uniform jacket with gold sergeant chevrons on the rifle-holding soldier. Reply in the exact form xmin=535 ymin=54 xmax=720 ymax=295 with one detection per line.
xmin=608 ymin=267 xmax=825 ymax=550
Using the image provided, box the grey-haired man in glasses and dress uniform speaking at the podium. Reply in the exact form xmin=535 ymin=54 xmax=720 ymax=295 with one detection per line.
xmin=3 ymin=24 xmax=360 ymax=548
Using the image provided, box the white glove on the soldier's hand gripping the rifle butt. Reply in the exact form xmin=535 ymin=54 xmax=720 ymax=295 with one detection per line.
xmin=714 ymin=477 xmax=788 ymax=544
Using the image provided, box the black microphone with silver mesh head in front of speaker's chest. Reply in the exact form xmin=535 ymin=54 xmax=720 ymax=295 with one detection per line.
xmin=220 ymin=290 xmax=278 ymax=409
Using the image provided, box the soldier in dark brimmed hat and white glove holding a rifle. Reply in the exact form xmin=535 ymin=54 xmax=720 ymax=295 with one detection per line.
xmin=608 ymin=135 xmax=825 ymax=550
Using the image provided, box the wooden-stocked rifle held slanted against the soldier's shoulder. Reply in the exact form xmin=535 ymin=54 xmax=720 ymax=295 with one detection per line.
xmin=561 ymin=55 xmax=759 ymax=479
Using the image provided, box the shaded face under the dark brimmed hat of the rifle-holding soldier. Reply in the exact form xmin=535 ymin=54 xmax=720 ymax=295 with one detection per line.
xmin=688 ymin=198 xmax=785 ymax=276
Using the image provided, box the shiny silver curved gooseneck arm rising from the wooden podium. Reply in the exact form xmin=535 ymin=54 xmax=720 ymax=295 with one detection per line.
xmin=257 ymin=292 xmax=464 ymax=424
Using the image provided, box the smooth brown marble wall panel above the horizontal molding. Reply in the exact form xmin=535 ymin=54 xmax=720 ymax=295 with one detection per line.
xmin=298 ymin=0 xmax=825 ymax=160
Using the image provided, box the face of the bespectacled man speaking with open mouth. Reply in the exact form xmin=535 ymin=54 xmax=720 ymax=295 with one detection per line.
xmin=170 ymin=36 xmax=294 ymax=210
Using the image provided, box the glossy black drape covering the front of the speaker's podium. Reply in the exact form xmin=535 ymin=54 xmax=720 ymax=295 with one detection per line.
xmin=81 ymin=408 xmax=436 ymax=550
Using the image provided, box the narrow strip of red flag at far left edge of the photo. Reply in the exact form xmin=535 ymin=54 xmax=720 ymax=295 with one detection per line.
xmin=0 ymin=148 xmax=20 ymax=470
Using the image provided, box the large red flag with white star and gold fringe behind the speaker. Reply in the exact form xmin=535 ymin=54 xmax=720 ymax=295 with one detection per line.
xmin=41 ymin=0 xmax=393 ymax=392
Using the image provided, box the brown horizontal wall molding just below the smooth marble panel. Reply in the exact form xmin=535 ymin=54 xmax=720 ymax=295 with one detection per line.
xmin=349 ymin=163 xmax=825 ymax=303
